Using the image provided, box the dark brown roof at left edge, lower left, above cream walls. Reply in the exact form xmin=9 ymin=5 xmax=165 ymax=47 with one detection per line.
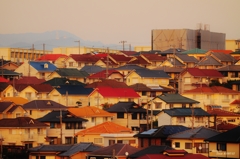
xmin=0 ymin=117 xmax=48 ymax=128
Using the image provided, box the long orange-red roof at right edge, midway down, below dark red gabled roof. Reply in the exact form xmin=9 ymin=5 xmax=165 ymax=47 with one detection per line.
xmin=184 ymin=86 xmax=239 ymax=94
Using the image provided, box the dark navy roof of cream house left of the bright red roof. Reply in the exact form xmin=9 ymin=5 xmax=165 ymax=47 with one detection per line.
xmin=55 ymin=85 xmax=93 ymax=95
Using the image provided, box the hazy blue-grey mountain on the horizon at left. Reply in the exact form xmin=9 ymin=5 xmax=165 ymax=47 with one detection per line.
xmin=0 ymin=30 xmax=107 ymax=50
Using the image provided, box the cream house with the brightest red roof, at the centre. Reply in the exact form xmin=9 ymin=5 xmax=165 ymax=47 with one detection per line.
xmin=88 ymin=87 xmax=140 ymax=107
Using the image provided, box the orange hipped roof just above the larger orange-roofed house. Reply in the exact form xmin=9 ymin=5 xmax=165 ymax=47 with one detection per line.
xmin=68 ymin=106 xmax=114 ymax=117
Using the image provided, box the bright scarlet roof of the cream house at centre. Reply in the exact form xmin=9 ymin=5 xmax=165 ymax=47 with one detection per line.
xmin=94 ymin=87 xmax=140 ymax=98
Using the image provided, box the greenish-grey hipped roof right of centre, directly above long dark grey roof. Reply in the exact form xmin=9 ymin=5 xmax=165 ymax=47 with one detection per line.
xmin=156 ymin=93 xmax=199 ymax=104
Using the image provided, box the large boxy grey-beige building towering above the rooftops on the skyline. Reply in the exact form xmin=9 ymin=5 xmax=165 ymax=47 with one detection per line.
xmin=151 ymin=25 xmax=226 ymax=51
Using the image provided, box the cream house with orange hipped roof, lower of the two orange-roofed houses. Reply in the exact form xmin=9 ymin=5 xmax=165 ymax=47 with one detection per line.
xmin=75 ymin=121 xmax=135 ymax=146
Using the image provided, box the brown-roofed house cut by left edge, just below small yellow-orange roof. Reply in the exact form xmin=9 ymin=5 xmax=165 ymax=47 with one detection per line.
xmin=0 ymin=101 xmax=27 ymax=119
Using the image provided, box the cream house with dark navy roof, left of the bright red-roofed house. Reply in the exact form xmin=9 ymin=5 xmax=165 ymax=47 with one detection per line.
xmin=48 ymin=84 xmax=94 ymax=107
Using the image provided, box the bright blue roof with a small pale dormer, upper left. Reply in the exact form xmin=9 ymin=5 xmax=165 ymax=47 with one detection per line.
xmin=29 ymin=61 xmax=57 ymax=72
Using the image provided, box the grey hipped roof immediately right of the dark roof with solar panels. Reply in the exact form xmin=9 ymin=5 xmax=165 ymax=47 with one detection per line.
xmin=168 ymin=126 xmax=220 ymax=139
